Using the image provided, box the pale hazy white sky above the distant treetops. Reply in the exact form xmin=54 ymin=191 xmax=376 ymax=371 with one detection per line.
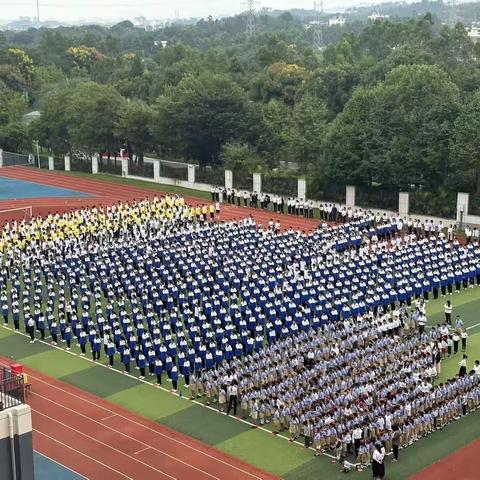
xmin=0 ymin=0 xmax=370 ymax=20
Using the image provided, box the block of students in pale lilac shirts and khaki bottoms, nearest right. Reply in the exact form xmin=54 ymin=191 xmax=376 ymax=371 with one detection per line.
xmin=206 ymin=310 xmax=480 ymax=463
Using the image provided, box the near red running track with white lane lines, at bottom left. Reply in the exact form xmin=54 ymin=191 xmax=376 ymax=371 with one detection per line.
xmin=2 ymin=362 xmax=277 ymax=480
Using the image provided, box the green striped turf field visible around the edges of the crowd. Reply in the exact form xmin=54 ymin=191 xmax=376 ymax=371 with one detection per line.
xmin=0 ymin=287 xmax=480 ymax=480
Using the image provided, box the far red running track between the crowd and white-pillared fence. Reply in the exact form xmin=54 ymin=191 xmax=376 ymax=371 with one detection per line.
xmin=0 ymin=167 xmax=318 ymax=231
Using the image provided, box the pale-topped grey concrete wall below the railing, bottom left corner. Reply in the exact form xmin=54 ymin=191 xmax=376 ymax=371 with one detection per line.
xmin=0 ymin=405 xmax=34 ymax=480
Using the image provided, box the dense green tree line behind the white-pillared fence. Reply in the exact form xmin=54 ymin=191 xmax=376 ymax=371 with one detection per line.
xmin=0 ymin=12 xmax=480 ymax=214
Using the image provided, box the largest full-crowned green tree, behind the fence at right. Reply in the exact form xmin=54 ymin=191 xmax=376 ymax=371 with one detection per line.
xmin=324 ymin=65 xmax=460 ymax=188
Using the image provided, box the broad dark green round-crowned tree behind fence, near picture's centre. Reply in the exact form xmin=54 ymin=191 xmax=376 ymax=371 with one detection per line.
xmin=154 ymin=74 xmax=260 ymax=165
